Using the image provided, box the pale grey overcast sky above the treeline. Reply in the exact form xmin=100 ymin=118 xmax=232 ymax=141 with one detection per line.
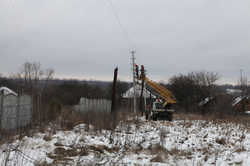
xmin=0 ymin=0 xmax=250 ymax=83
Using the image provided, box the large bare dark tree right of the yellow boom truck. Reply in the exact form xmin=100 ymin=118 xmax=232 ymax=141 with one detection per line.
xmin=169 ymin=71 xmax=219 ymax=110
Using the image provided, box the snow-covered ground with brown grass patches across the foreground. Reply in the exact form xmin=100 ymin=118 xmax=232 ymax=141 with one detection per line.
xmin=0 ymin=118 xmax=250 ymax=166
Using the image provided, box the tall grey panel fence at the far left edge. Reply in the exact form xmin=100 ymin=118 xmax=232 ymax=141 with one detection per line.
xmin=0 ymin=95 xmax=32 ymax=130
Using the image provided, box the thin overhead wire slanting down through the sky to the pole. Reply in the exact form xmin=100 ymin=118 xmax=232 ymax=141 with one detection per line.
xmin=107 ymin=0 xmax=135 ymax=50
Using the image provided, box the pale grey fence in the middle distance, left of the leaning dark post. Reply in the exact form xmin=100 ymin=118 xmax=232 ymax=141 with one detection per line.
xmin=74 ymin=98 xmax=111 ymax=113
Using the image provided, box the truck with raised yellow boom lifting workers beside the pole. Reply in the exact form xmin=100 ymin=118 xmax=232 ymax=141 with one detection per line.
xmin=136 ymin=65 xmax=177 ymax=121
